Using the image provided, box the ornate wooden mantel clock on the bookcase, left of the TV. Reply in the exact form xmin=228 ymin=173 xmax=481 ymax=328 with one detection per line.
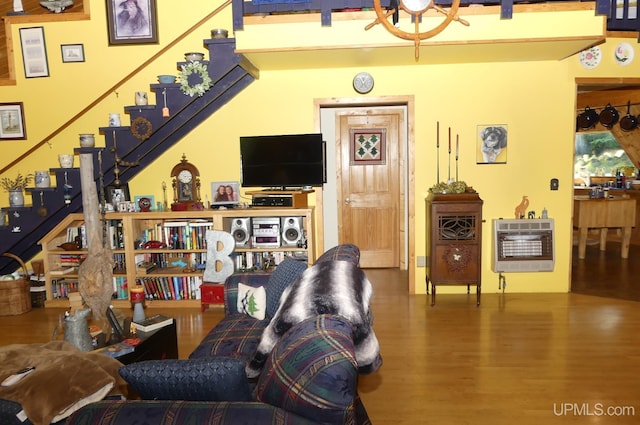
xmin=171 ymin=154 xmax=204 ymax=211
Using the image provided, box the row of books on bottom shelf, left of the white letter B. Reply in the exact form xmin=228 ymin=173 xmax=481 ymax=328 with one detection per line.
xmin=136 ymin=276 xmax=202 ymax=301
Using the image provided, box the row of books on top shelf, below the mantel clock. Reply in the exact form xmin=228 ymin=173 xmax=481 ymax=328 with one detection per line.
xmin=140 ymin=220 xmax=213 ymax=249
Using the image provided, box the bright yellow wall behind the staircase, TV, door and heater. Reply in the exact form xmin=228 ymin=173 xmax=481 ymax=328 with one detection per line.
xmin=0 ymin=0 xmax=640 ymax=293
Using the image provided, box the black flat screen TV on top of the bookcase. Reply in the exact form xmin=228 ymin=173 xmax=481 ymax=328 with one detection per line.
xmin=240 ymin=133 xmax=327 ymax=189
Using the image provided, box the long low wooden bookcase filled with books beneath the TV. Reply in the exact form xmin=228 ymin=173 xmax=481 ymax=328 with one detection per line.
xmin=39 ymin=208 xmax=315 ymax=308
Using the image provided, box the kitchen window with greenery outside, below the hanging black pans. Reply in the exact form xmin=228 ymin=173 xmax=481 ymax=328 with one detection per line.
xmin=573 ymin=131 xmax=635 ymax=187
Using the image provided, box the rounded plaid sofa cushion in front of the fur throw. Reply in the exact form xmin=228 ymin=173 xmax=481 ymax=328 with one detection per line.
xmin=254 ymin=315 xmax=358 ymax=423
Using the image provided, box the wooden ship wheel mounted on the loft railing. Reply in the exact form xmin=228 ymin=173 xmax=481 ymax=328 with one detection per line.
xmin=365 ymin=0 xmax=469 ymax=61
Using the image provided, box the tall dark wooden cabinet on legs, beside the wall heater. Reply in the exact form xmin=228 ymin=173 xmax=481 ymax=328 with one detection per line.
xmin=426 ymin=193 xmax=483 ymax=305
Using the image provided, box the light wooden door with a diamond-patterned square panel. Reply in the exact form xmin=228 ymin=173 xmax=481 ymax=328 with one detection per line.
xmin=336 ymin=108 xmax=406 ymax=267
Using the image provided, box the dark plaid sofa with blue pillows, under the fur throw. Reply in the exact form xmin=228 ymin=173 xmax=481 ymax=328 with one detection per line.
xmin=66 ymin=245 xmax=370 ymax=425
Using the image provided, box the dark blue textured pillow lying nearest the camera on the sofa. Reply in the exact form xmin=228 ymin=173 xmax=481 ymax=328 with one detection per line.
xmin=118 ymin=357 xmax=251 ymax=401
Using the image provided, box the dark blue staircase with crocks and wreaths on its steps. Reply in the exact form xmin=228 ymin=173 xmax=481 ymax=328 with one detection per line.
xmin=0 ymin=38 xmax=258 ymax=275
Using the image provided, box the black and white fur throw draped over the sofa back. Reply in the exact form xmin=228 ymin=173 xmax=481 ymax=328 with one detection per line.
xmin=246 ymin=261 xmax=382 ymax=378
